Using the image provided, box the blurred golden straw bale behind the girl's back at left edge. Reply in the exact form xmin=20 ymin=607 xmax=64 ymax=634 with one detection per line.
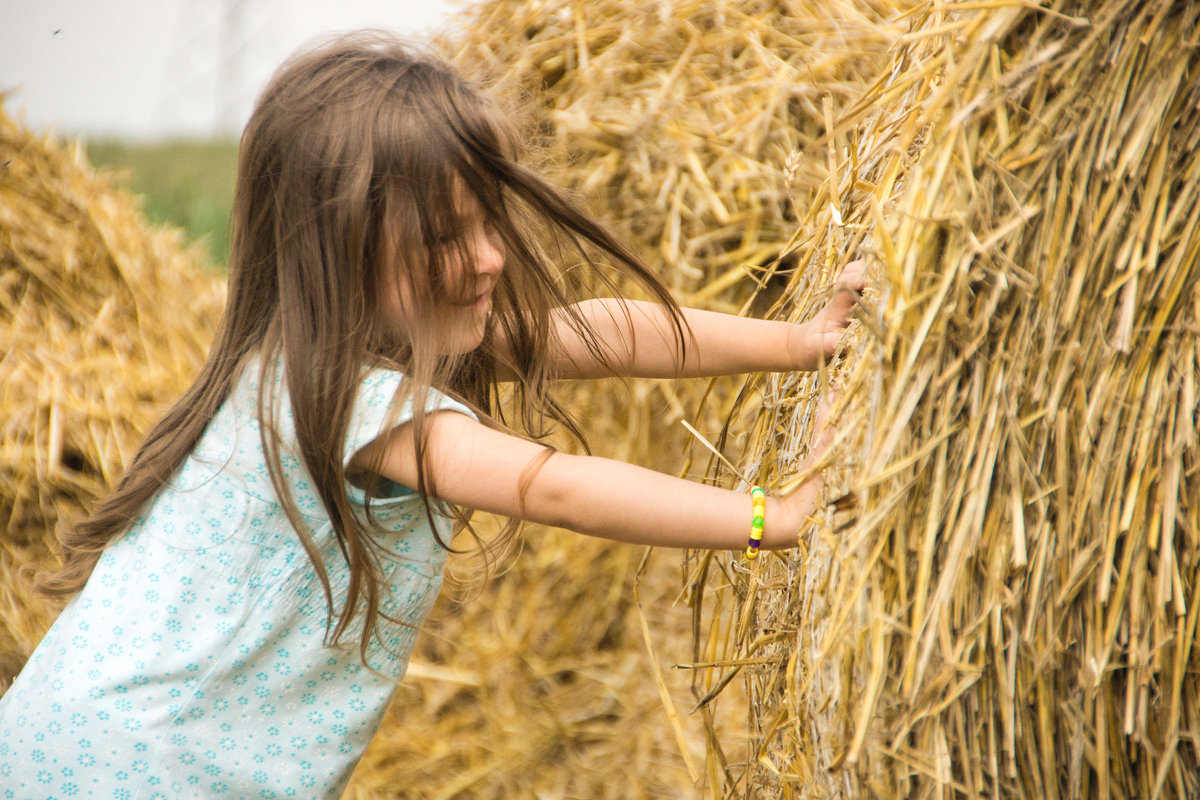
xmin=0 ymin=101 xmax=222 ymax=686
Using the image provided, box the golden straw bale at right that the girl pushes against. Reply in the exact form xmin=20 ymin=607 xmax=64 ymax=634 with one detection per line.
xmin=700 ymin=0 xmax=1200 ymax=798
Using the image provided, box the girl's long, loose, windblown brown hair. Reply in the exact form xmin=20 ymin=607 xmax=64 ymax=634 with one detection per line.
xmin=43 ymin=32 xmax=684 ymax=652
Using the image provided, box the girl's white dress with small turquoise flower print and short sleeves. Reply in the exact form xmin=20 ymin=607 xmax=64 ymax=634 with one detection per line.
xmin=0 ymin=365 xmax=472 ymax=800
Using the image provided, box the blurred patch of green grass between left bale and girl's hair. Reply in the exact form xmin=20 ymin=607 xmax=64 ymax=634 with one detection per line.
xmin=88 ymin=139 xmax=238 ymax=264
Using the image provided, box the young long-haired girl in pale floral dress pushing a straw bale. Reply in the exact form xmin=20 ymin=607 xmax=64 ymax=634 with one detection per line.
xmin=0 ymin=35 xmax=863 ymax=799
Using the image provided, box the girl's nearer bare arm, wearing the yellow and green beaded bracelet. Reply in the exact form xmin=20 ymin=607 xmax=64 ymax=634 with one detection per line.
xmin=352 ymin=411 xmax=824 ymax=549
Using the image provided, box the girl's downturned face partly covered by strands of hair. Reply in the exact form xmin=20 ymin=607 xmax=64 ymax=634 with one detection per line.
xmin=384 ymin=191 xmax=505 ymax=355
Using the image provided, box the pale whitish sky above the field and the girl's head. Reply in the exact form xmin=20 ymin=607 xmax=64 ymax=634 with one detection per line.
xmin=0 ymin=0 xmax=469 ymax=139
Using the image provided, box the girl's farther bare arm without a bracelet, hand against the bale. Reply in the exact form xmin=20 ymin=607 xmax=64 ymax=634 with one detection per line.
xmin=501 ymin=261 xmax=865 ymax=378
